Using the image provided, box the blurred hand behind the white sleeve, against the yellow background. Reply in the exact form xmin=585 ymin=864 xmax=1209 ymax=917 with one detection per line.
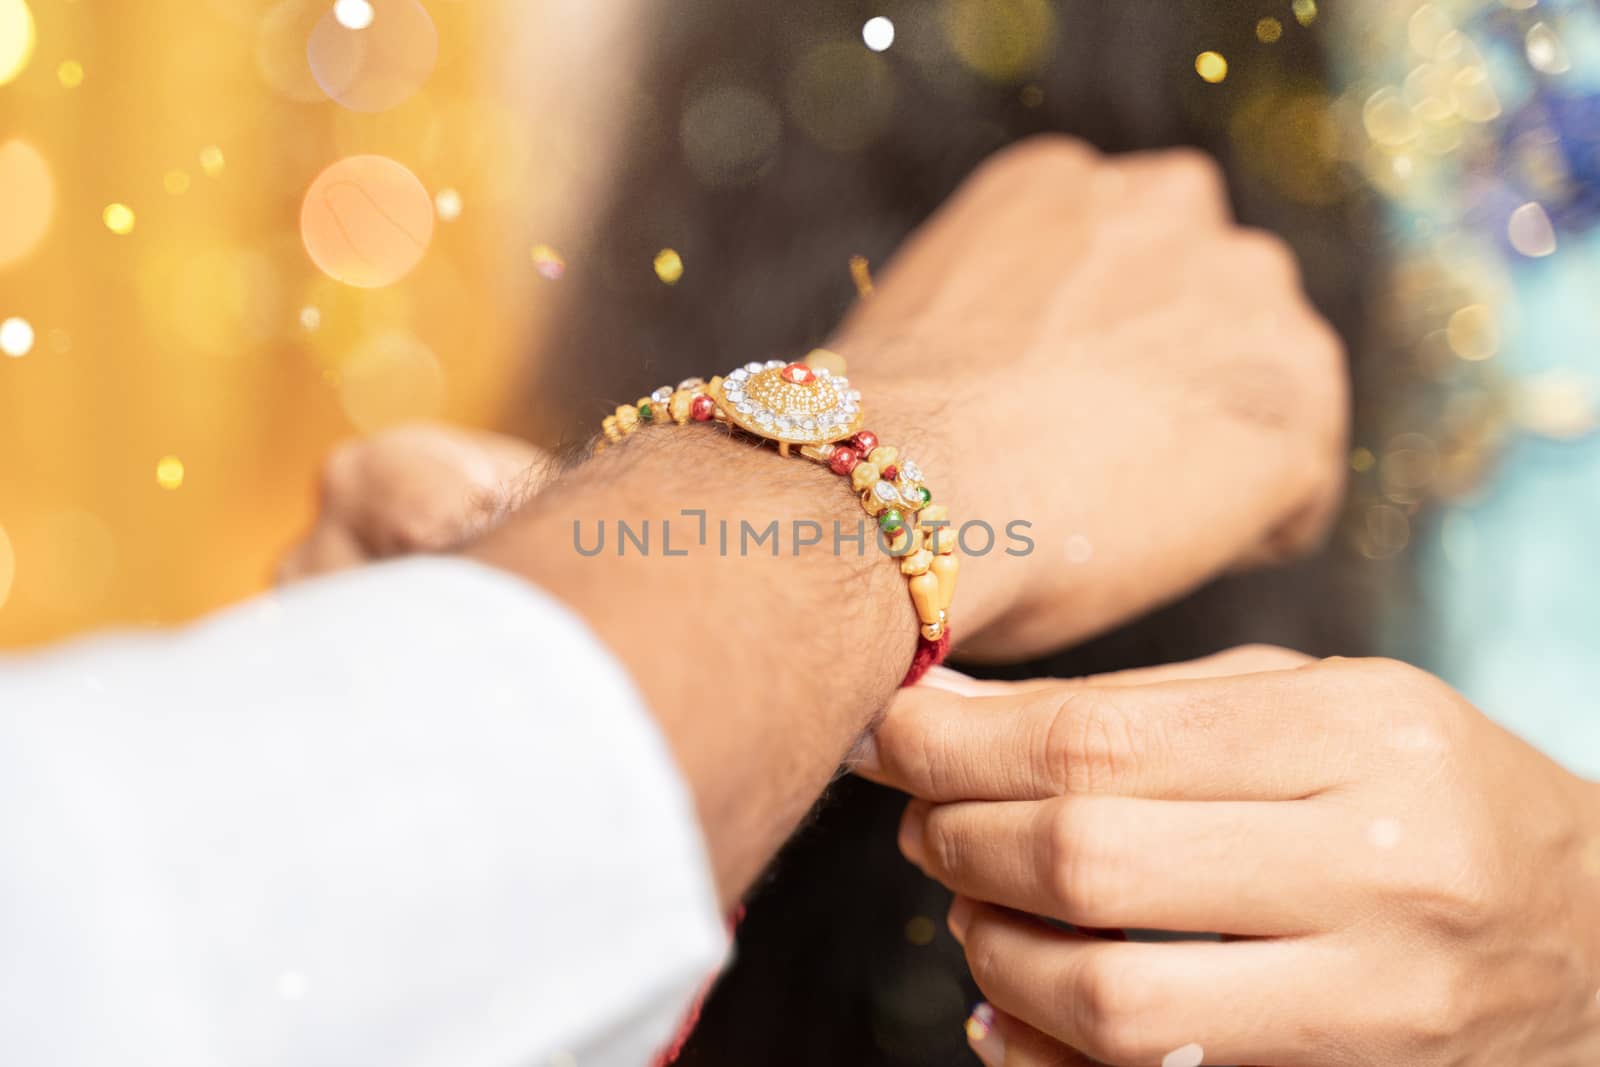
xmin=278 ymin=424 xmax=554 ymax=582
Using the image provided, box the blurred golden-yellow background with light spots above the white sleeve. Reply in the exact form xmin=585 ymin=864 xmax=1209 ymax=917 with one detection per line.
xmin=0 ymin=0 xmax=617 ymax=646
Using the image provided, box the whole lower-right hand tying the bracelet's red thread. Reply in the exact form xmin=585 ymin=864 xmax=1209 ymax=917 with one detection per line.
xmin=861 ymin=649 xmax=1600 ymax=1067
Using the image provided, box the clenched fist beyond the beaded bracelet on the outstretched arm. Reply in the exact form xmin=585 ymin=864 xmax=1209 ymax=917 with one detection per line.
xmin=834 ymin=138 xmax=1347 ymax=659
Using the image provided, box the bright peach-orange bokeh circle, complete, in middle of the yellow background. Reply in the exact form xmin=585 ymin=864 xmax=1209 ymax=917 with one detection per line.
xmin=301 ymin=155 xmax=434 ymax=290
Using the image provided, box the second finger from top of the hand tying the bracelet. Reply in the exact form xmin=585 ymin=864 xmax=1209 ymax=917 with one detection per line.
xmin=901 ymin=795 xmax=1337 ymax=936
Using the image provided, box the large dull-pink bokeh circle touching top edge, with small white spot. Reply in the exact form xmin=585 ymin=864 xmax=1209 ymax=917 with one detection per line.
xmin=306 ymin=0 xmax=438 ymax=112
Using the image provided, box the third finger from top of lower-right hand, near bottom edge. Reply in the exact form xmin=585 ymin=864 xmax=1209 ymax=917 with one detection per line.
xmin=950 ymin=897 xmax=1349 ymax=1067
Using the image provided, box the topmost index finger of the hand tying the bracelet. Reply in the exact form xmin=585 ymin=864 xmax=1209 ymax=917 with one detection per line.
xmin=856 ymin=655 xmax=1355 ymax=801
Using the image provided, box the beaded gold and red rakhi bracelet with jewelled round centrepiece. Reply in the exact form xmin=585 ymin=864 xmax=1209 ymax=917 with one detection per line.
xmin=597 ymin=349 xmax=960 ymax=685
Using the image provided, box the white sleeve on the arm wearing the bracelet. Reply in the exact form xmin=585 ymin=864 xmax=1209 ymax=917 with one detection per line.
xmin=0 ymin=560 xmax=726 ymax=1067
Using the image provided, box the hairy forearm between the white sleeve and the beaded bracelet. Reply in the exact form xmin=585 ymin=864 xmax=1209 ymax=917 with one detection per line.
xmin=472 ymin=412 xmax=917 ymax=901
